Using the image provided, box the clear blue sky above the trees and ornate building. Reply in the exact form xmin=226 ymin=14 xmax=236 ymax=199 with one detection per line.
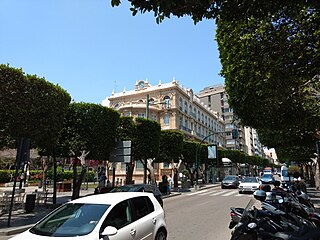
xmin=0 ymin=0 xmax=224 ymax=103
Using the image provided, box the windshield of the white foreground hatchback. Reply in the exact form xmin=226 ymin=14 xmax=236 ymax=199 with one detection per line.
xmin=30 ymin=203 xmax=110 ymax=237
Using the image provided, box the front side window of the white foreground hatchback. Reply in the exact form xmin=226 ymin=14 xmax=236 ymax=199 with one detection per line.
xmin=101 ymin=200 xmax=132 ymax=232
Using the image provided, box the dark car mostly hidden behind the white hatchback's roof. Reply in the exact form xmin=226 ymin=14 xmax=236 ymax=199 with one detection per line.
xmin=110 ymin=183 xmax=163 ymax=207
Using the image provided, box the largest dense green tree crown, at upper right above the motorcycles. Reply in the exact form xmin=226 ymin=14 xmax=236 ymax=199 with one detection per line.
xmin=216 ymin=2 xmax=320 ymax=131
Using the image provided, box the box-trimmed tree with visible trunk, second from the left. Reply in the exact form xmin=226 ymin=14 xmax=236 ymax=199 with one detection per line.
xmin=57 ymin=103 xmax=120 ymax=199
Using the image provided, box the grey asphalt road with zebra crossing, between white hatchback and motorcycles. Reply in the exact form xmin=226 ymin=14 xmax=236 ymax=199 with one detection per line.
xmin=164 ymin=187 xmax=258 ymax=240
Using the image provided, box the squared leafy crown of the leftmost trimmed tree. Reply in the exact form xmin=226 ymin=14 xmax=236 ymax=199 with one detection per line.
xmin=0 ymin=64 xmax=71 ymax=149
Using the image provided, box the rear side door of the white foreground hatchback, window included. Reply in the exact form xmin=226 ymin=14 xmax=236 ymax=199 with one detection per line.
xmin=131 ymin=196 xmax=157 ymax=240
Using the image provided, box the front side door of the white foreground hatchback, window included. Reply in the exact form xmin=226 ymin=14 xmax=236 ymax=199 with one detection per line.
xmin=100 ymin=200 xmax=141 ymax=240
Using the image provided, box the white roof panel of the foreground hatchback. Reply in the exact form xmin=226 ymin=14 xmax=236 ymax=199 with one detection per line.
xmin=70 ymin=192 xmax=154 ymax=205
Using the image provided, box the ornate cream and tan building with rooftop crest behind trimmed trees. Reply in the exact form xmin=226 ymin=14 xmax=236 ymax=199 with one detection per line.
xmin=104 ymin=79 xmax=226 ymax=182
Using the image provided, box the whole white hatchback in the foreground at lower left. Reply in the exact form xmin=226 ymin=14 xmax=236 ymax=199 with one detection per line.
xmin=11 ymin=192 xmax=168 ymax=240
